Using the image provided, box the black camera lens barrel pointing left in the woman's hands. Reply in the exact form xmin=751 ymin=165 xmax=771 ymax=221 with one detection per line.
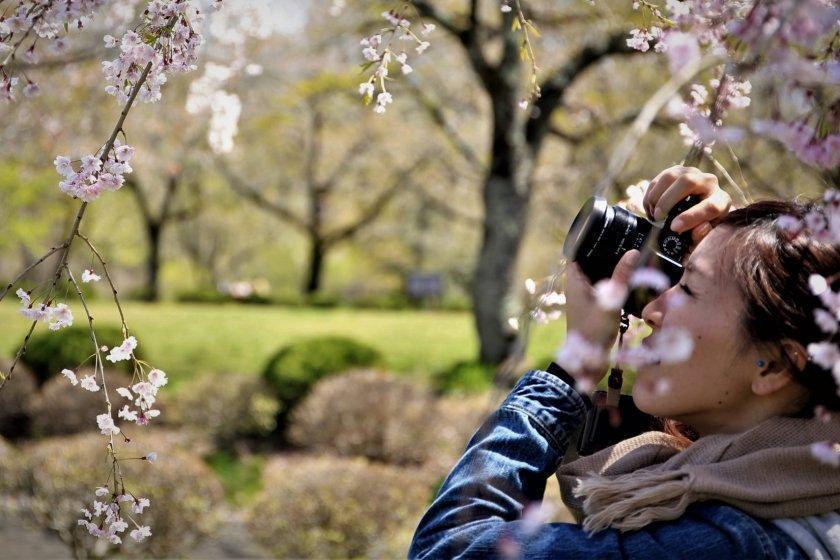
xmin=563 ymin=196 xmax=653 ymax=283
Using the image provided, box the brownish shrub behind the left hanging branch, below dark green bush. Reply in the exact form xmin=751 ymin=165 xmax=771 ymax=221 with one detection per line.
xmin=32 ymin=369 xmax=131 ymax=437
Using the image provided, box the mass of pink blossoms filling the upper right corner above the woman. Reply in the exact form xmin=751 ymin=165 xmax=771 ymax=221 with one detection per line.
xmin=627 ymin=0 xmax=840 ymax=169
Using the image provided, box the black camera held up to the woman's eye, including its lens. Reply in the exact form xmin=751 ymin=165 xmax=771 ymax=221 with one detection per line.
xmin=563 ymin=196 xmax=699 ymax=317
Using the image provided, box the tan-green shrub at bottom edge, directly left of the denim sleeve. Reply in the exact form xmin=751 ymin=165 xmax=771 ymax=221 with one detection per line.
xmin=241 ymin=456 xmax=431 ymax=558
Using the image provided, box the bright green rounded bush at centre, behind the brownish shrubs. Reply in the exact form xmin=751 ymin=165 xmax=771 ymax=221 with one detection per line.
xmin=263 ymin=336 xmax=382 ymax=421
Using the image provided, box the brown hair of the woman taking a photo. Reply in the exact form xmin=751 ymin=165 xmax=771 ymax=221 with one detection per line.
xmin=717 ymin=200 xmax=840 ymax=416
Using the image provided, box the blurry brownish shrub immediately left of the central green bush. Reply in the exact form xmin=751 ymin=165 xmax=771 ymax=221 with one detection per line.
xmin=166 ymin=375 xmax=280 ymax=449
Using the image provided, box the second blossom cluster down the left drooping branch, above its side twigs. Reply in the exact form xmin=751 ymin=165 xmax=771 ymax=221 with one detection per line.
xmin=53 ymin=139 xmax=134 ymax=203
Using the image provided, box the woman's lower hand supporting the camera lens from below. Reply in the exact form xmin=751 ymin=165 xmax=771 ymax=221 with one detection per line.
xmin=565 ymin=249 xmax=640 ymax=385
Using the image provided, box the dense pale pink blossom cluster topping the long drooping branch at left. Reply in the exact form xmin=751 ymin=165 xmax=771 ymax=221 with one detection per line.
xmin=102 ymin=0 xmax=203 ymax=105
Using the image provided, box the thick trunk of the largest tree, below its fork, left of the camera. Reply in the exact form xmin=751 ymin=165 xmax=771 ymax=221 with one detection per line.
xmin=472 ymin=92 xmax=533 ymax=365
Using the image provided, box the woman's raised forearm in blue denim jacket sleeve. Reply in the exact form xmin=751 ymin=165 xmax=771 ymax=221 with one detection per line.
xmin=409 ymin=371 xmax=585 ymax=559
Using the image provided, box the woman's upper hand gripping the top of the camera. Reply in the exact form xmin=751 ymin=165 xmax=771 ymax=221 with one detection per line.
xmin=643 ymin=165 xmax=732 ymax=246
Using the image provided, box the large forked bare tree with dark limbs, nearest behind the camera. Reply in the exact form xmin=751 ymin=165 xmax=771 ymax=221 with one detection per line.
xmin=413 ymin=0 xmax=631 ymax=364
